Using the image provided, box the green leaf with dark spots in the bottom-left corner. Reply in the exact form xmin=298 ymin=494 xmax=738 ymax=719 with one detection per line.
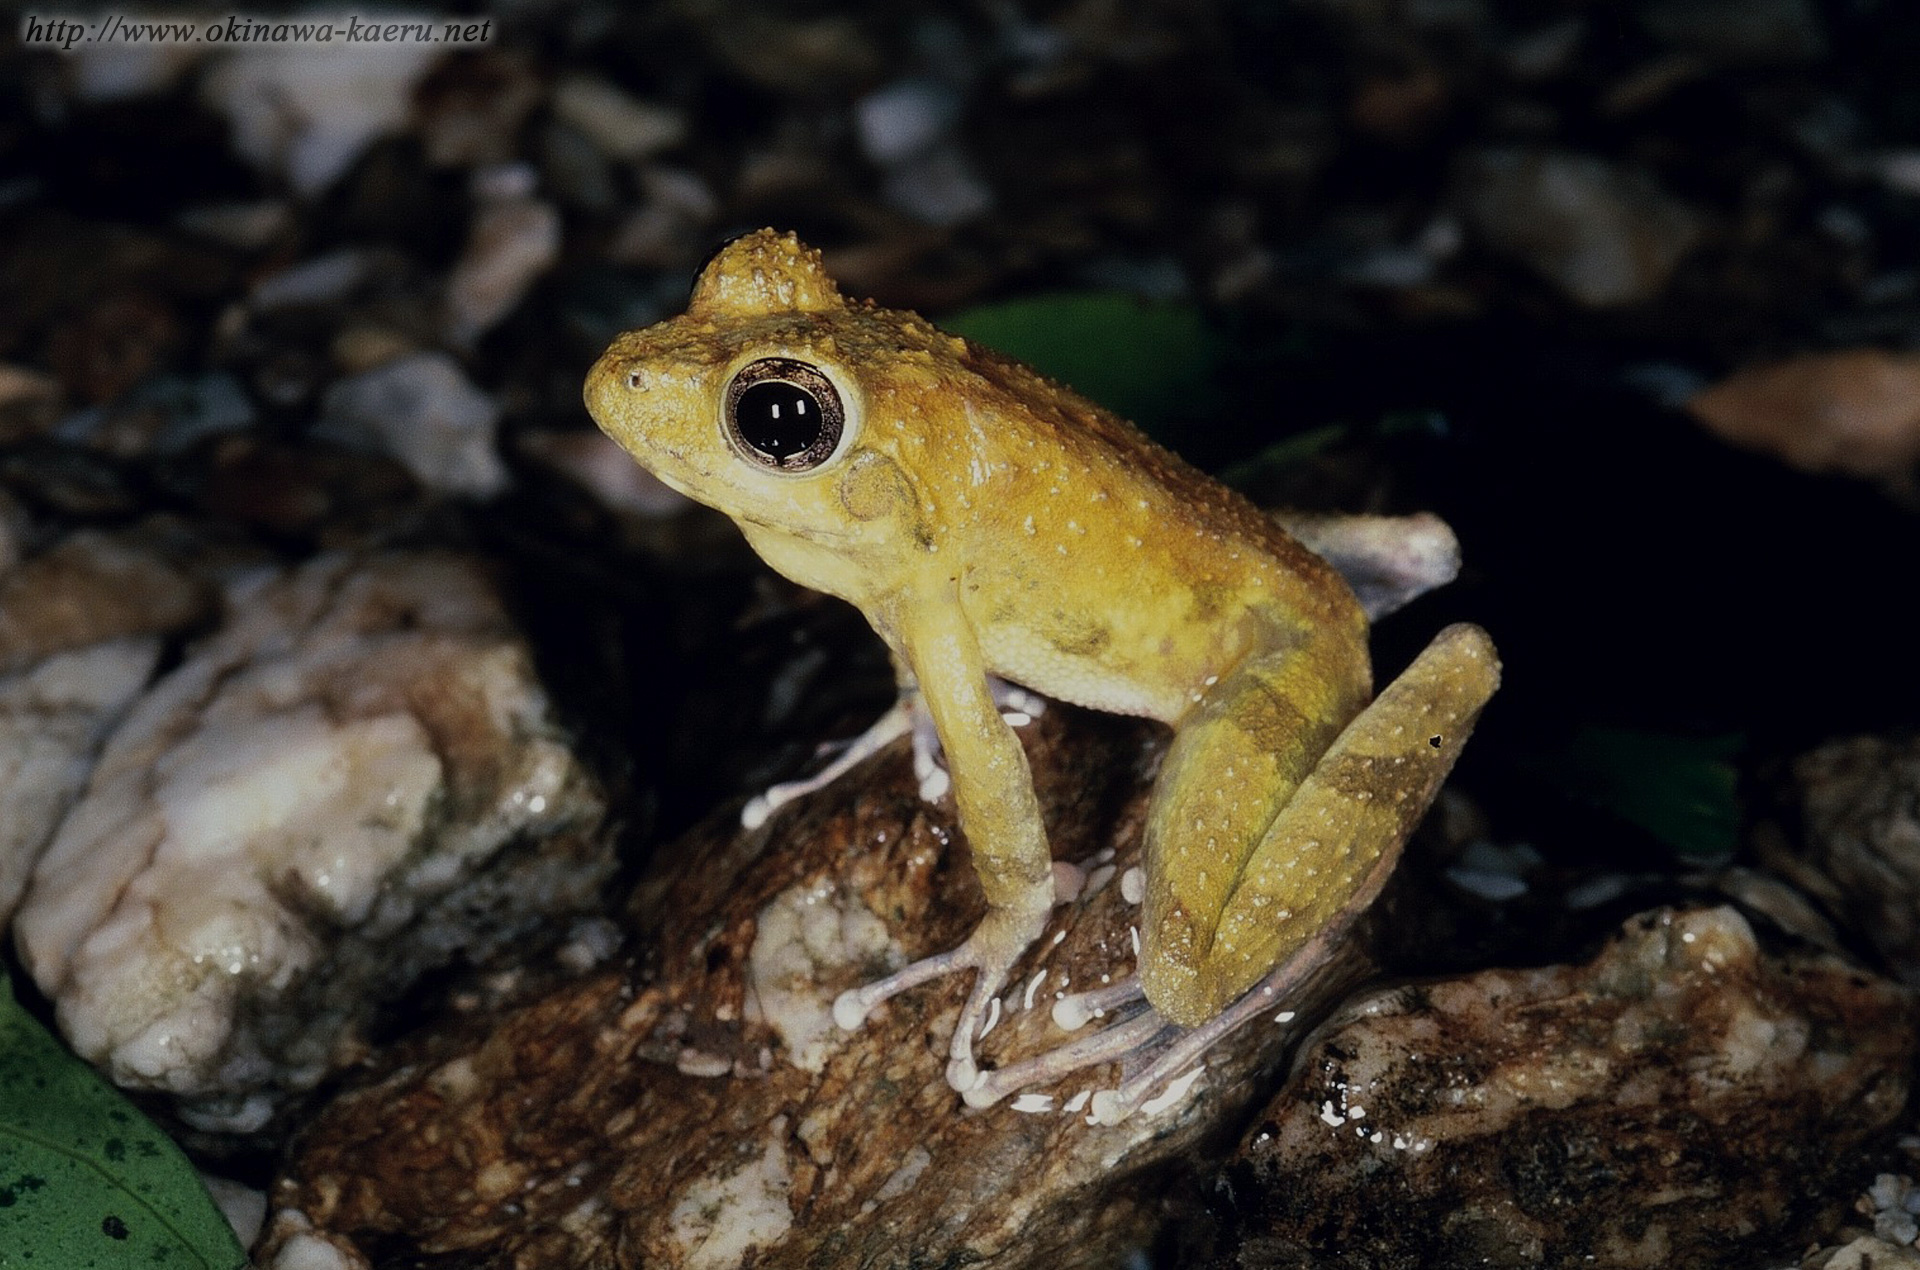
xmin=0 ymin=974 xmax=246 ymax=1270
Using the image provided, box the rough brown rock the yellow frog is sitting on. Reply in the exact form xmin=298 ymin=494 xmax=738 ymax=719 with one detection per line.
xmin=259 ymin=707 xmax=1390 ymax=1268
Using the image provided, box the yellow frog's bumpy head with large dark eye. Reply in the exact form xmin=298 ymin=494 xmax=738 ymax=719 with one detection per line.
xmin=586 ymin=229 xmax=950 ymax=542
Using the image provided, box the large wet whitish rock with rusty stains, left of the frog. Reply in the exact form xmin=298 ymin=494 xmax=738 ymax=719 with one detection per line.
xmin=15 ymin=555 xmax=611 ymax=1132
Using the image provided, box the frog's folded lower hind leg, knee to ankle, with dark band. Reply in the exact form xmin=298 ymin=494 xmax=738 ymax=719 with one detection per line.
xmin=1140 ymin=624 xmax=1500 ymax=1026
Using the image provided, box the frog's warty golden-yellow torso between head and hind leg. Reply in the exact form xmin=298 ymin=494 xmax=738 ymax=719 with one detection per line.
xmin=921 ymin=344 xmax=1365 ymax=720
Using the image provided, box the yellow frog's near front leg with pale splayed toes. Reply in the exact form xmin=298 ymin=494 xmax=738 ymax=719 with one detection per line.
xmin=833 ymin=586 xmax=1054 ymax=1091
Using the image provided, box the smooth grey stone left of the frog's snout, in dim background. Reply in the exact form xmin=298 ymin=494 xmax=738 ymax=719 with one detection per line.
xmin=313 ymin=352 xmax=507 ymax=498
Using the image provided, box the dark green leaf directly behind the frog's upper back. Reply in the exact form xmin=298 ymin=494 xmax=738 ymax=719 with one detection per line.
xmin=941 ymin=292 xmax=1221 ymax=432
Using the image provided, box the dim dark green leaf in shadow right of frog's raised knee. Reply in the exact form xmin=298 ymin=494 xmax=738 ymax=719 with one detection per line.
xmin=1528 ymin=726 xmax=1745 ymax=859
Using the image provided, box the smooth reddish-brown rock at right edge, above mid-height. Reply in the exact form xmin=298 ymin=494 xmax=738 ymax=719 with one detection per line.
xmin=1686 ymin=348 xmax=1920 ymax=480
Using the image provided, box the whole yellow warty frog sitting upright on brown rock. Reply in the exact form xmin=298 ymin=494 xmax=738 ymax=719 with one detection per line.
xmin=584 ymin=229 xmax=1501 ymax=1120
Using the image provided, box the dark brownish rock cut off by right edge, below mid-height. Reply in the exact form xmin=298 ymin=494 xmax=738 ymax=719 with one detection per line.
xmin=1761 ymin=736 xmax=1920 ymax=986
